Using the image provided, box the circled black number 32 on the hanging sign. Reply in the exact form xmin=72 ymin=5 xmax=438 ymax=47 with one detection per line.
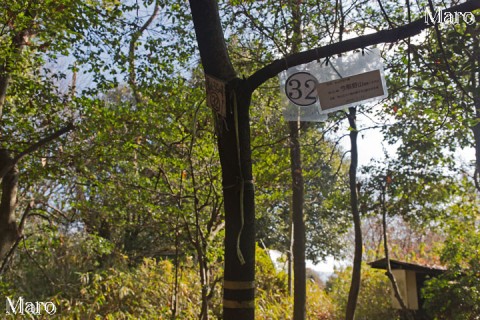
xmin=285 ymin=72 xmax=318 ymax=107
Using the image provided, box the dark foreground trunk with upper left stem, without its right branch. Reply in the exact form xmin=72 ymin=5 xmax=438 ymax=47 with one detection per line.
xmin=190 ymin=0 xmax=255 ymax=320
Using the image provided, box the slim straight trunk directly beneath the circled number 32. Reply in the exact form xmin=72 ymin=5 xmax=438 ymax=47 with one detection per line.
xmin=288 ymin=121 xmax=306 ymax=320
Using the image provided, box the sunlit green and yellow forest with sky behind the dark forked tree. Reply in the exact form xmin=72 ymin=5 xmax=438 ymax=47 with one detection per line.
xmin=0 ymin=0 xmax=480 ymax=319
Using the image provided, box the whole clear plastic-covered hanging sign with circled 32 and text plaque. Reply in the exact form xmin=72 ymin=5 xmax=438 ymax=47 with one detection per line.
xmin=279 ymin=48 xmax=388 ymax=122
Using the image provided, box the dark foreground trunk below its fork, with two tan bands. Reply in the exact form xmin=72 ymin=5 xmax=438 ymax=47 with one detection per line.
xmin=218 ymin=81 xmax=255 ymax=319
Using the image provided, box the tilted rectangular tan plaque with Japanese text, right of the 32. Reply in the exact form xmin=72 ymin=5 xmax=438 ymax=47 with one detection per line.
xmin=317 ymin=70 xmax=385 ymax=111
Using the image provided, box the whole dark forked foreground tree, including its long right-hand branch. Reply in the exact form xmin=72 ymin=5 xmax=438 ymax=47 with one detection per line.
xmin=189 ymin=0 xmax=480 ymax=320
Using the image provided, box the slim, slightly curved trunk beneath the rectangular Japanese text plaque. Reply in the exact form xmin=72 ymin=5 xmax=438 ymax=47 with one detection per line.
xmin=345 ymin=108 xmax=363 ymax=320
